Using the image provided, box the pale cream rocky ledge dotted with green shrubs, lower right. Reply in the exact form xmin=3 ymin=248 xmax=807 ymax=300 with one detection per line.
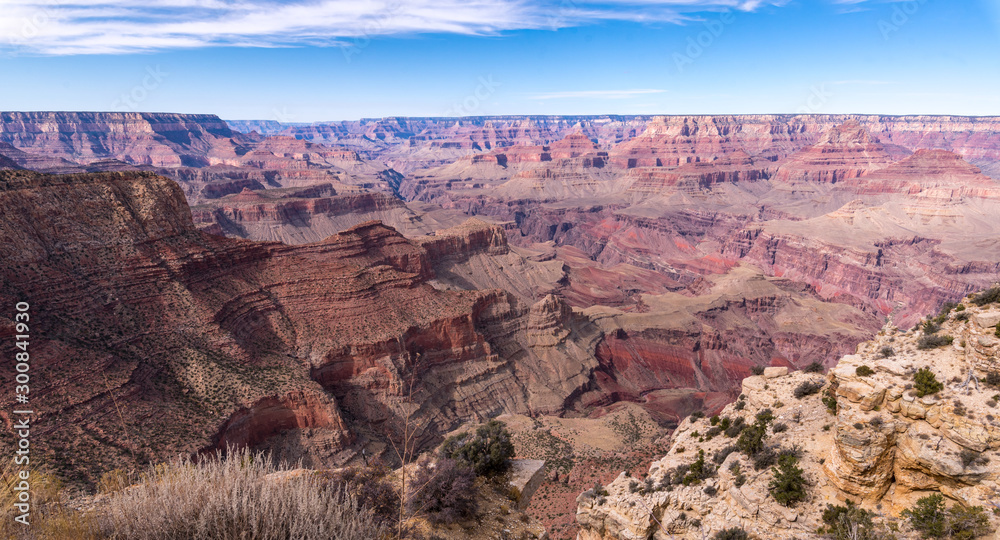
xmin=577 ymin=298 xmax=1000 ymax=540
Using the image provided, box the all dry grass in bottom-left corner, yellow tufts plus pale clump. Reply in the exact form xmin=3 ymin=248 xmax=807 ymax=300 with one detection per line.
xmin=0 ymin=451 xmax=391 ymax=540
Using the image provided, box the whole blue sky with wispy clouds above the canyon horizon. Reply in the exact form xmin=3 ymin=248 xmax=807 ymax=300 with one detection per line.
xmin=0 ymin=0 xmax=1000 ymax=122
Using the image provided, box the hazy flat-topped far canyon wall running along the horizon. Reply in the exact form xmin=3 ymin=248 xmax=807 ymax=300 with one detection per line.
xmin=238 ymin=115 xmax=1000 ymax=172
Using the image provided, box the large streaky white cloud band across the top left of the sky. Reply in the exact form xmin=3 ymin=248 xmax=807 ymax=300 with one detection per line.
xmin=0 ymin=0 xmax=860 ymax=55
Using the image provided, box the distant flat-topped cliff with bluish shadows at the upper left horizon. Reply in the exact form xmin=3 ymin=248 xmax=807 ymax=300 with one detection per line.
xmin=0 ymin=112 xmax=398 ymax=202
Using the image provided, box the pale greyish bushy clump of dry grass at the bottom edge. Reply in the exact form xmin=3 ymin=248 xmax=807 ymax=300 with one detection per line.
xmin=99 ymin=451 xmax=387 ymax=540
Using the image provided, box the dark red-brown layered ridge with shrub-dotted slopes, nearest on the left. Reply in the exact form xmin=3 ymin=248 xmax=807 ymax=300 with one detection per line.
xmin=0 ymin=172 xmax=562 ymax=481
